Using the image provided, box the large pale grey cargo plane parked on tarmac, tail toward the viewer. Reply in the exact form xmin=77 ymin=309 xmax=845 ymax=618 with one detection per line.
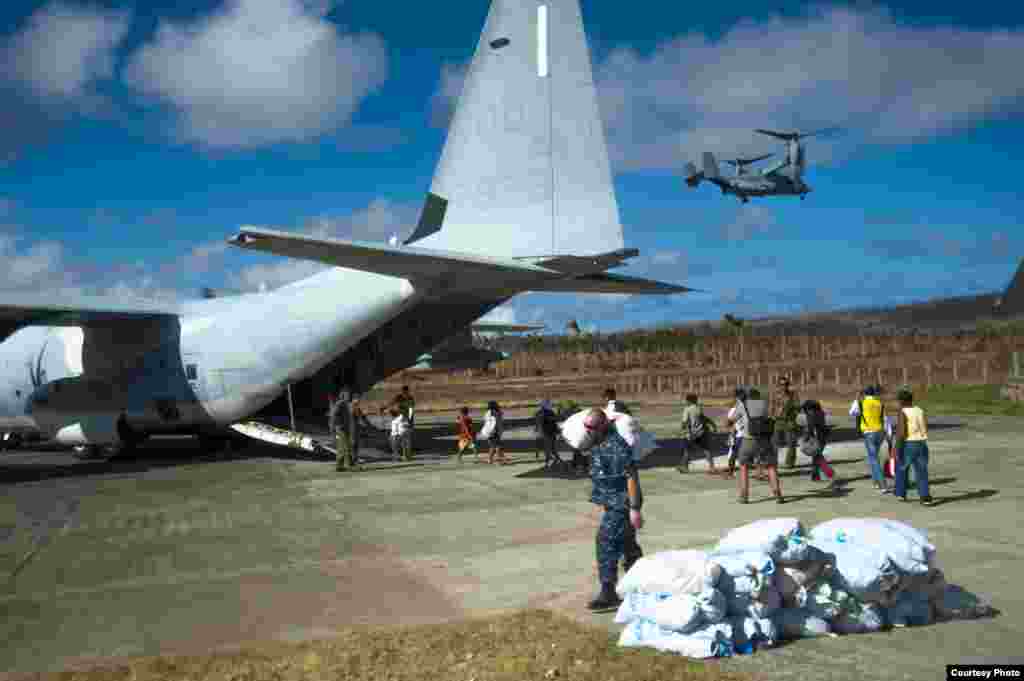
xmin=0 ymin=0 xmax=691 ymax=453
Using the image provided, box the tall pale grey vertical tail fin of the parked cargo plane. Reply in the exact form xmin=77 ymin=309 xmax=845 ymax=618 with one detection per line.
xmin=406 ymin=0 xmax=625 ymax=257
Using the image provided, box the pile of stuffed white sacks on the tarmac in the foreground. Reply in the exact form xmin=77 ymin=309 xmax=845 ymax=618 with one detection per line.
xmin=615 ymin=518 xmax=991 ymax=657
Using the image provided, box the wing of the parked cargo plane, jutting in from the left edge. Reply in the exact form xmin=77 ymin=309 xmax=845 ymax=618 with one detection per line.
xmin=0 ymin=293 xmax=180 ymax=340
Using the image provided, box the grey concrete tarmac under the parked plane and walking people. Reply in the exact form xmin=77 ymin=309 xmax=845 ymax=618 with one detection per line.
xmin=0 ymin=408 xmax=1024 ymax=679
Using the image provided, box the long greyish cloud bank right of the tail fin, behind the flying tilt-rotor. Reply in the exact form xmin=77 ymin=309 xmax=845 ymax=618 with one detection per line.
xmin=595 ymin=8 xmax=1024 ymax=170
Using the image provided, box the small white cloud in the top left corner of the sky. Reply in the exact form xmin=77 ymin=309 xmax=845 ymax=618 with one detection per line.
xmin=2 ymin=2 xmax=129 ymax=98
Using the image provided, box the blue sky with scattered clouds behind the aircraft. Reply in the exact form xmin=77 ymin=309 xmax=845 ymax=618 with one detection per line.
xmin=0 ymin=0 xmax=1024 ymax=331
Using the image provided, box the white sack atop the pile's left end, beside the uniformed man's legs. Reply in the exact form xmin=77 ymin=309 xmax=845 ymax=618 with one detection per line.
xmin=615 ymin=550 xmax=721 ymax=596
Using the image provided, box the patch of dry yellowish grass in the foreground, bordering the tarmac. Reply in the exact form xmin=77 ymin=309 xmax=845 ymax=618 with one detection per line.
xmin=32 ymin=610 xmax=752 ymax=681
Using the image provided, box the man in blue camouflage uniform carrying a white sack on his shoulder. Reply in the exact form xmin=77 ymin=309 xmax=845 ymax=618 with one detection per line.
xmin=584 ymin=410 xmax=643 ymax=610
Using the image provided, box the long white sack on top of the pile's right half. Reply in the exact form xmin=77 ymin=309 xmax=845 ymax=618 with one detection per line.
xmin=811 ymin=518 xmax=935 ymax=574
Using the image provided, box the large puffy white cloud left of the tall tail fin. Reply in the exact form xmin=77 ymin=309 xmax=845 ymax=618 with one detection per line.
xmin=125 ymin=0 xmax=387 ymax=147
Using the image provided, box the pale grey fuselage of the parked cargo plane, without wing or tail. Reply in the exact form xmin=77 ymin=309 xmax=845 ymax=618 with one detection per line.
xmin=0 ymin=268 xmax=418 ymax=444
